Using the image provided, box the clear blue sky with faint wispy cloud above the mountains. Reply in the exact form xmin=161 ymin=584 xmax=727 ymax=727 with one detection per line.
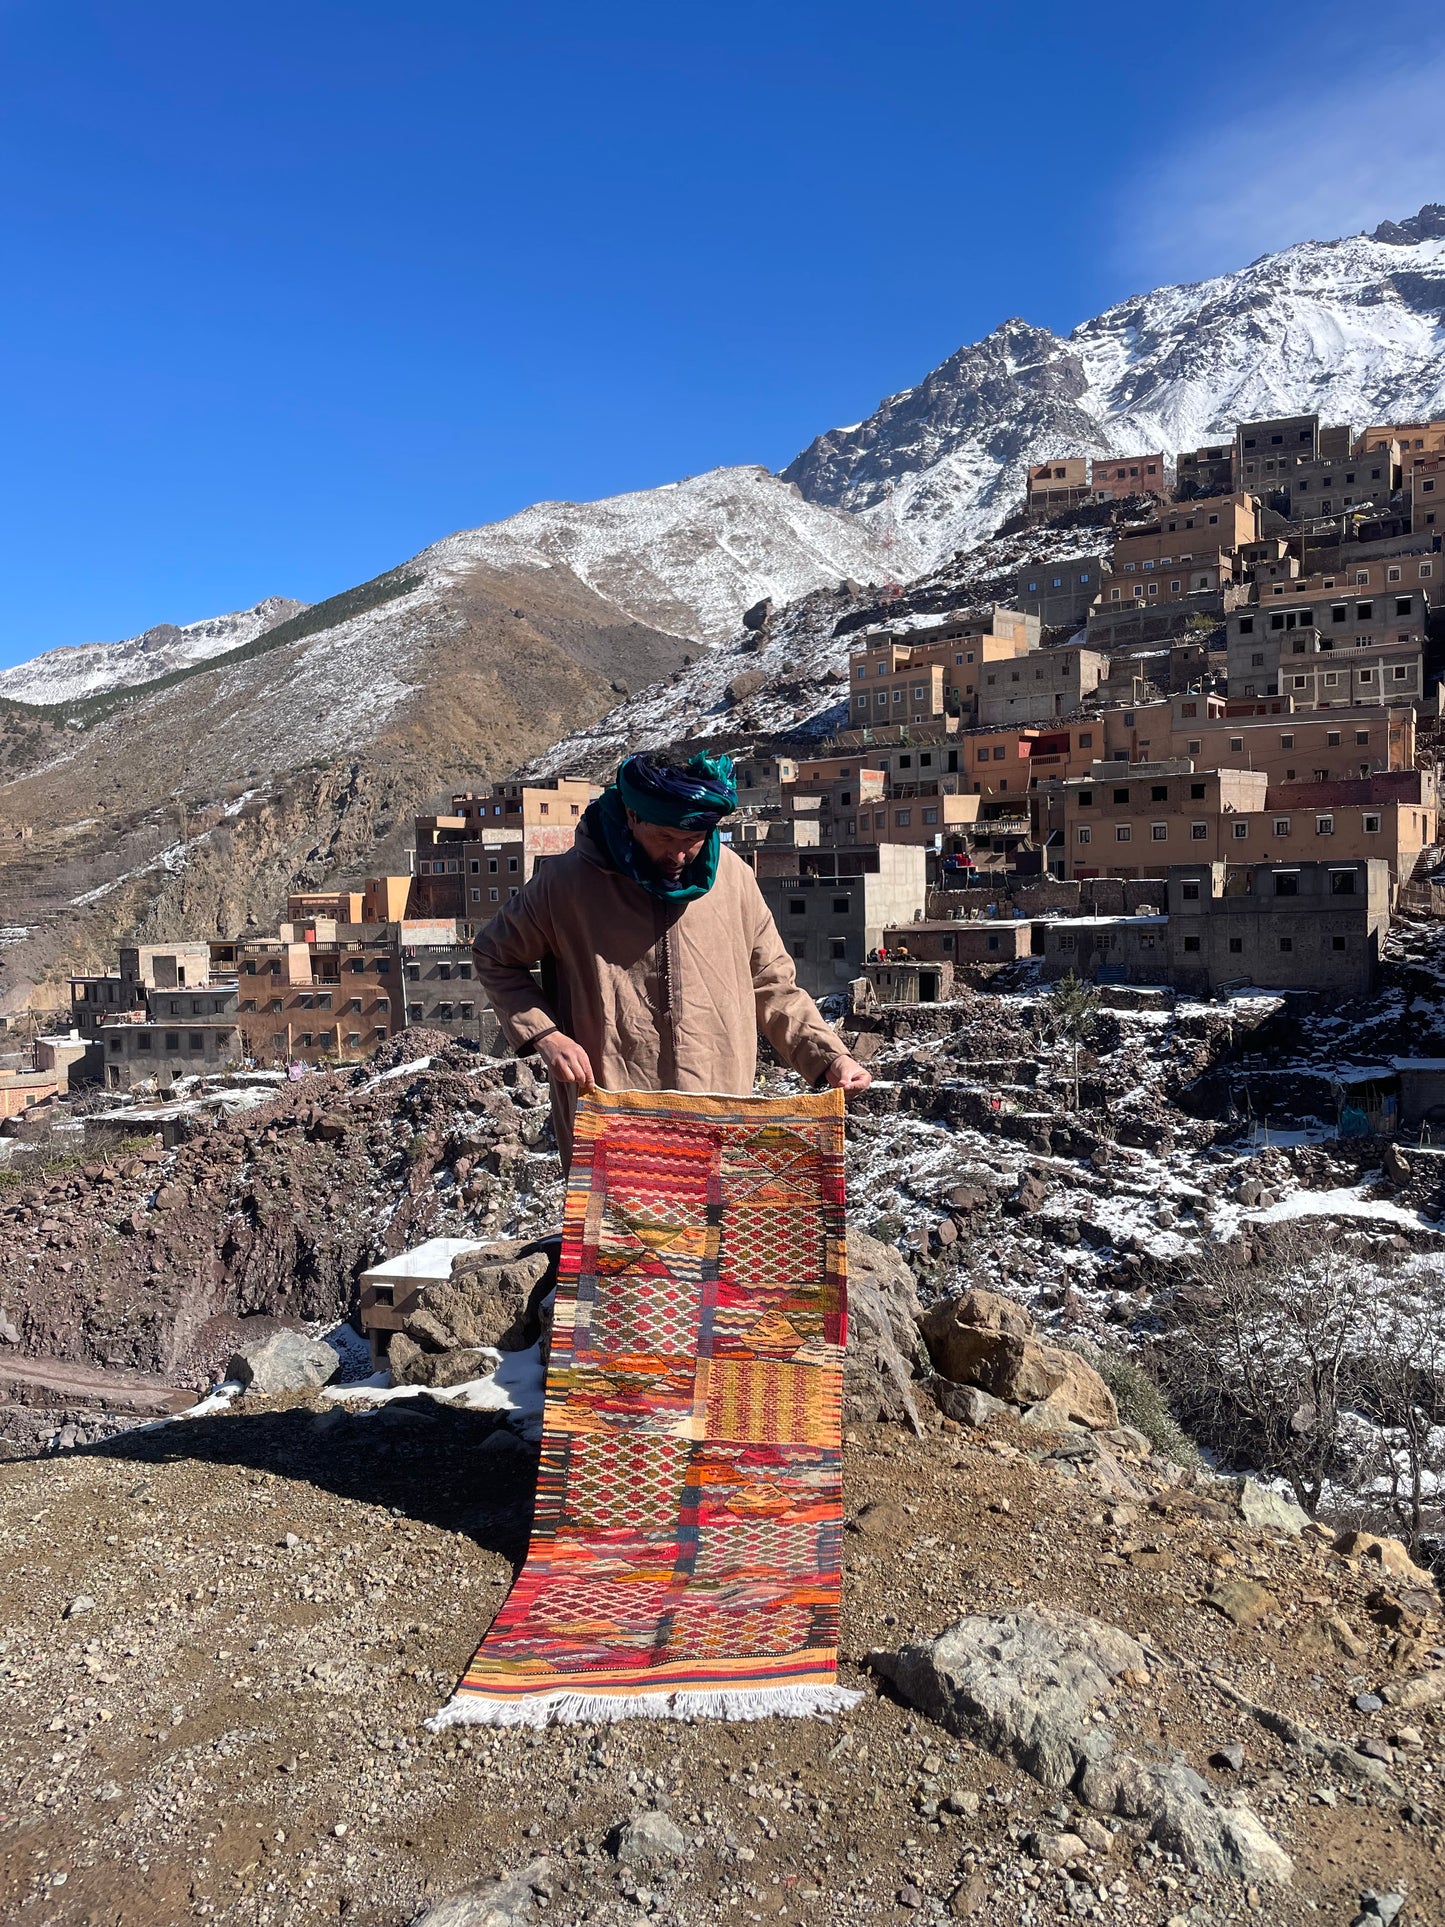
xmin=0 ymin=0 xmax=1445 ymax=663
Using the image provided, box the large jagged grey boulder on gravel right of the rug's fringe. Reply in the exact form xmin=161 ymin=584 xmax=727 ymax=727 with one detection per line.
xmin=869 ymin=1607 xmax=1291 ymax=1883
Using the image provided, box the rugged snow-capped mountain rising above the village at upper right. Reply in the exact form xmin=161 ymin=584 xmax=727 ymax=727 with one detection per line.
xmin=782 ymin=206 xmax=1445 ymax=561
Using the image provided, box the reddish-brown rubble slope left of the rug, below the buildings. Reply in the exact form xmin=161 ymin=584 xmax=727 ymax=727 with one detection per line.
xmin=0 ymin=1031 xmax=561 ymax=1438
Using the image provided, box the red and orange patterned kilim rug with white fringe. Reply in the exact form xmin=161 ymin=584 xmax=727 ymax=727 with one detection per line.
xmin=430 ymin=1091 xmax=859 ymax=1727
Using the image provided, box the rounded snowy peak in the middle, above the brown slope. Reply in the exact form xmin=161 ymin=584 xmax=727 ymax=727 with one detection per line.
xmin=416 ymin=468 xmax=917 ymax=642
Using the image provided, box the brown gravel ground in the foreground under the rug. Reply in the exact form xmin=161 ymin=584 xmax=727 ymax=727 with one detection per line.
xmin=0 ymin=1399 xmax=1445 ymax=1927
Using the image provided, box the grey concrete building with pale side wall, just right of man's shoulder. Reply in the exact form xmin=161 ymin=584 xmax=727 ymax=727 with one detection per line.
xmin=757 ymin=842 xmax=927 ymax=996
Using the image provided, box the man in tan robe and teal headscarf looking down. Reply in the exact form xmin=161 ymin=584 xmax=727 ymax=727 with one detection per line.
xmin=474 ymin=755 xmax=871 ymax=1168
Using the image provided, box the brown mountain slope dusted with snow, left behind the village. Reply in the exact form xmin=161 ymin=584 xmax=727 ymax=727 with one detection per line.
xmin=0 ymin=559 xmax=686 ymax=1010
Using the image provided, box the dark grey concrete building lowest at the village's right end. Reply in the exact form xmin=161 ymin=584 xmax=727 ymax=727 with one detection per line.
xmin=1168 ymin=859 xmax=1389 ymax=996
